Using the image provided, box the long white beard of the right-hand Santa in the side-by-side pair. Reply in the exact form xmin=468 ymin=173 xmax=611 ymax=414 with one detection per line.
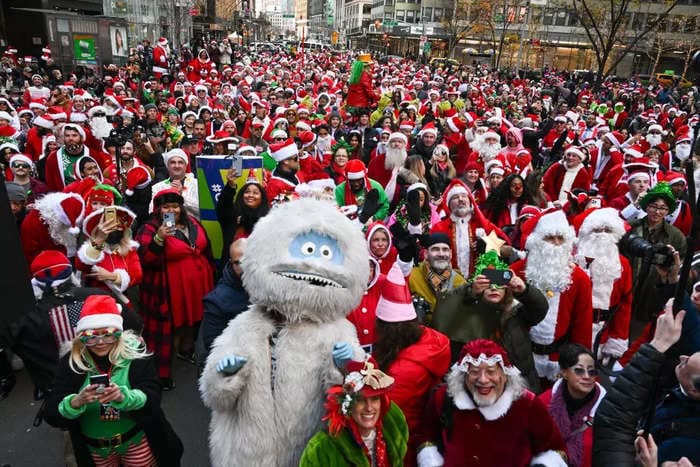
xmin=578 ymin=232 xmax=622 ymax=310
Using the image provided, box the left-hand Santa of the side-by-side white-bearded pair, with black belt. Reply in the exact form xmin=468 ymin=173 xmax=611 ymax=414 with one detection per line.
xmin=511 ymin=209 xmax=593 ymax=381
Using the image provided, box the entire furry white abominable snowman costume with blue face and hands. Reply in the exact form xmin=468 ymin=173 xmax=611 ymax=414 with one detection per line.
xmin=199 ymin=199 xmax=369 ymax=467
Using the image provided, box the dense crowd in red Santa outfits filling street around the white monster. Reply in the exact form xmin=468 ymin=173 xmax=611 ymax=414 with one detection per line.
xmin=0 ymin=38 xmax=700 ymax=467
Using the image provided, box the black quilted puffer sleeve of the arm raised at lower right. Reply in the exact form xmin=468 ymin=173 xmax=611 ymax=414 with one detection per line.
xmin=593 ymin=344 xmax=665 ymax=467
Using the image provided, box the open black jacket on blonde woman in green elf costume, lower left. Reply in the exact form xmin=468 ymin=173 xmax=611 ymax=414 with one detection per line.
xmin=44 ymin=355 xmax=184 ymax=467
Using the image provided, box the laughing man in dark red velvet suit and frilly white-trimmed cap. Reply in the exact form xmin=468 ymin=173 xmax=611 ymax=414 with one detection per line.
xmin=416 ymin=339 xmax=567 ymax=467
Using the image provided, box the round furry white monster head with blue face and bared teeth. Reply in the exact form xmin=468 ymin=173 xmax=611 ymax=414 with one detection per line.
xmin=241 ymin=199 xmax=369 ymax=322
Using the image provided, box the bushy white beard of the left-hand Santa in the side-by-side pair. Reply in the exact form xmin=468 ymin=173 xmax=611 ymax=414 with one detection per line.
xmin=525 ymin=239 xmax=573 ymax=292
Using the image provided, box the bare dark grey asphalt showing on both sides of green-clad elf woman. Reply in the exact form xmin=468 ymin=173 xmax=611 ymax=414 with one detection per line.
xmin=0 ymin=360 xmax=209 ymax=467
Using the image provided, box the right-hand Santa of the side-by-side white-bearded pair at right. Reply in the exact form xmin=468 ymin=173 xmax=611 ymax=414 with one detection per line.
xmin=574 ymin=208 xmax=632 ymax=363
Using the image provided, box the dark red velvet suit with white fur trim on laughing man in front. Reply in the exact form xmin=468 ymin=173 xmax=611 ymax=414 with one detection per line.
xmin=417 ymin=339 xmax=566 ymax=467
